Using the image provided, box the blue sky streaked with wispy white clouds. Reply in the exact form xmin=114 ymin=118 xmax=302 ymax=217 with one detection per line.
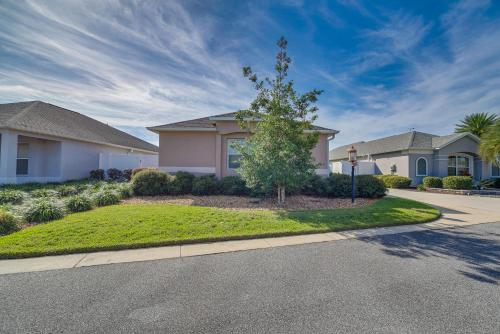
xmin=0 ymin=0 xmax=500 ymax=147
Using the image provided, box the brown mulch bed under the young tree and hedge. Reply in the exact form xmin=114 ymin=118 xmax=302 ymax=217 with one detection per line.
xmin=124 ymin=195 xmax=377 ymax=210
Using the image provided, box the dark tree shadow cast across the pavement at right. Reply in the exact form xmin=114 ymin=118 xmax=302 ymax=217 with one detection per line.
xmin=360 ymin=230 xmax=500 ymax=285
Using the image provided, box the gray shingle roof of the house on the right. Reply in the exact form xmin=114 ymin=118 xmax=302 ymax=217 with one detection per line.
xmin=330 ymin=131 xmax=479 ymax=160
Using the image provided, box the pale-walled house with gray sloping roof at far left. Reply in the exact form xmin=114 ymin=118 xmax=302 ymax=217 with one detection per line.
xmin=0 ymin=101 xmax=158 ymax=183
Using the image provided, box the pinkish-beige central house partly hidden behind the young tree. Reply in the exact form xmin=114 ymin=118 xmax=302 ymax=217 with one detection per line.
xmin=148 ymin=112 xmax=338 ymax=178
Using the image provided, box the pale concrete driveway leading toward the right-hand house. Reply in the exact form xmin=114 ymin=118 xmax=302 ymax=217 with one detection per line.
xmin=389 ymin=189 xmax=500 ymax=226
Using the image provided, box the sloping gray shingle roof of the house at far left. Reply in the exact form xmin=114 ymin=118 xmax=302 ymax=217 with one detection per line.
xmin=0 ymin=101 xmax=158 ymax=152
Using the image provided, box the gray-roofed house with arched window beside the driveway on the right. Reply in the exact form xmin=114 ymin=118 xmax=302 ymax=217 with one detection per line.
xmin=330 ymin=131 xmax=500 ymax=185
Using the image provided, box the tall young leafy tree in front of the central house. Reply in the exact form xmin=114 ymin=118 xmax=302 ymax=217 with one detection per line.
xmin=236 ymin=37 xmax=321 ymax=204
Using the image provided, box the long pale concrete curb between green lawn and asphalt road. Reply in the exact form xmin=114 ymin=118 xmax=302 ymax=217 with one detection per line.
xmin=0 ymin=218 xmax=495 ymax=275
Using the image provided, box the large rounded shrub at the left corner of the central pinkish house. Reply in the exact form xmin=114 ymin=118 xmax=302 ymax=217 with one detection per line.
xmin=132 ymin=169 xmax=170 ymax=196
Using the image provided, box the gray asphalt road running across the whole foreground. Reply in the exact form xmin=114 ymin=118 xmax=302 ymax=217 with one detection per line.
xmin=0 ymin=223 xmax=500 ymax=333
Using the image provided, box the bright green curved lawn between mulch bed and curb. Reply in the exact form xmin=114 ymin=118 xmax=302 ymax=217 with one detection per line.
xmin=0 ymin=197 xmax=439 ymax=258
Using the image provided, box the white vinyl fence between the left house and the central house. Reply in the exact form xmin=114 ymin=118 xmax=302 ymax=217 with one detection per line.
xmin=99 ymin=153 xmax=158 ymax=170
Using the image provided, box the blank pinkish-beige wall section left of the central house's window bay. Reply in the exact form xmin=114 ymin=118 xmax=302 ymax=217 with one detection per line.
xmin=159 ymin=131 xmax=216 ymax=174
